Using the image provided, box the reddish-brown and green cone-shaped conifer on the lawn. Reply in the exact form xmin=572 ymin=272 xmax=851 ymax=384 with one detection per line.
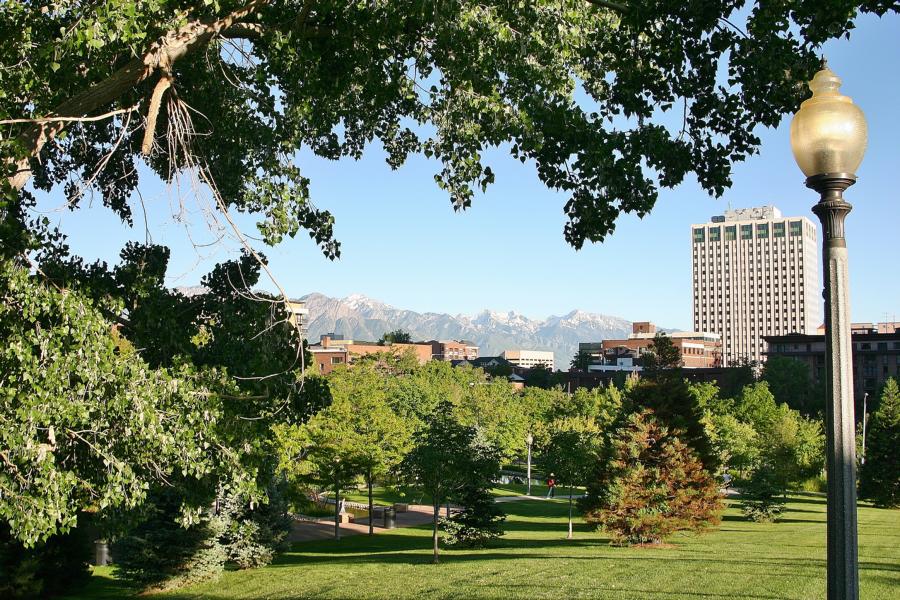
xmin=584 ymin=411 xmax=722 ymax=544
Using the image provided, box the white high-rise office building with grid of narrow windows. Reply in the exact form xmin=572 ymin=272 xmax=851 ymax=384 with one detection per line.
xmin=691 ymin=206 xmax=822 ymax=366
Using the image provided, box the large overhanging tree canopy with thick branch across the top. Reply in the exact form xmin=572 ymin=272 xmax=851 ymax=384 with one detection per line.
xmin=0 ymin=0 xmax=896 ymax=257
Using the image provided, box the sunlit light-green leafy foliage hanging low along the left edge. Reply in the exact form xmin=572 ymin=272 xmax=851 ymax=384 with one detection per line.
xmin=0 ymin=262 xmax=252 ymax=545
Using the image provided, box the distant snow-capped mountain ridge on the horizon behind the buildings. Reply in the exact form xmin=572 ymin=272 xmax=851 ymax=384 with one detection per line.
xmin=301 ymin=293 xmax=631 ymax=370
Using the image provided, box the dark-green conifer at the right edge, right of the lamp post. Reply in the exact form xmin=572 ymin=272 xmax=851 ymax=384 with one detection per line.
xmin=859 ymin=378 xmax=900 ymax=508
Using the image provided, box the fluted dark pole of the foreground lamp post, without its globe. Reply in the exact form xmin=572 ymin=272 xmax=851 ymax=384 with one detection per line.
xmin=806 ymin=173 xmax=859 ymax=600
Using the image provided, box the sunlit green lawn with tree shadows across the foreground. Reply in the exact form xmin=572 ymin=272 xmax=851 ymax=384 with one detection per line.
xmin=65 ymin=497 xmax=900 ymax=600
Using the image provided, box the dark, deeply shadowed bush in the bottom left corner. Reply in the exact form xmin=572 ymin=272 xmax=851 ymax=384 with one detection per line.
xmin=0 ymin=523 xmax=93 ymax=600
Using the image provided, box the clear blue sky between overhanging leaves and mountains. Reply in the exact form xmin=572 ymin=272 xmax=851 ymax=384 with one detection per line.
xmin=31 ymin=10 xmax=900 ymax=328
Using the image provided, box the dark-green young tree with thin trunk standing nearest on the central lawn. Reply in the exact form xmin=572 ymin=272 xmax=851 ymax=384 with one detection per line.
xmin=403 ymin=401 xmax=500 ymax=564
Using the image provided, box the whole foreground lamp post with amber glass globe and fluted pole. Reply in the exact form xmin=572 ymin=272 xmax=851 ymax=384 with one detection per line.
xmin=791 ymin=65 xmax=867 ymax=600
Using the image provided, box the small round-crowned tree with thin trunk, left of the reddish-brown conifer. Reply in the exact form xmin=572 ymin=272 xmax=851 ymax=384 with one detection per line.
xmin=541 ymin=418 xmax=602 ymax=539
